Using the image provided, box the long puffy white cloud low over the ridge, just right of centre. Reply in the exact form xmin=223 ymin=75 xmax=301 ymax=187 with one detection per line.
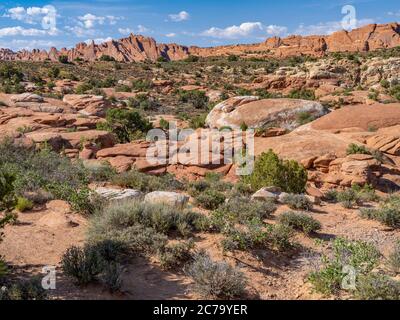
xmin=201 ymin=22 xmax=288 ymax=39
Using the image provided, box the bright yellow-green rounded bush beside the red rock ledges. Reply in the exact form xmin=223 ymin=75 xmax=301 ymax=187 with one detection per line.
xmin=244 ymin=150 xmax=307 ymax=193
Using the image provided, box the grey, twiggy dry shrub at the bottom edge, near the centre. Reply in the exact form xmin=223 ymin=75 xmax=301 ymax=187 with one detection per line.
xmin=185 ymin=253 xmax=246 ymax=298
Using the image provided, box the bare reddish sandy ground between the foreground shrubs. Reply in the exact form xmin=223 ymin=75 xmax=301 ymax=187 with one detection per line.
xmin=0 ymin=202 xmax=400 ymax=300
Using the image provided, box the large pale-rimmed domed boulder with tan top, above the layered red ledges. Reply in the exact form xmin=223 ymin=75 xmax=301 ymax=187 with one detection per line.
xmin=206 ymin=96 xmax=327 ymax=130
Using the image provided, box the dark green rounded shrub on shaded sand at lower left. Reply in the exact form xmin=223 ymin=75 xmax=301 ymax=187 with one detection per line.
xmin=61 ymin=246 xmax=104 ymax=285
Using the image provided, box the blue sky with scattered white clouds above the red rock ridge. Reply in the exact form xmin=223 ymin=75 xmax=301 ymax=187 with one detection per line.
xmin=0 ymin=0 xmax=400 ymax=50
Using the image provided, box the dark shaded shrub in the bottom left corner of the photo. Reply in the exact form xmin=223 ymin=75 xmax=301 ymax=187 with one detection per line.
xmin=0 ymin=277 xmax=47 ymax=301
